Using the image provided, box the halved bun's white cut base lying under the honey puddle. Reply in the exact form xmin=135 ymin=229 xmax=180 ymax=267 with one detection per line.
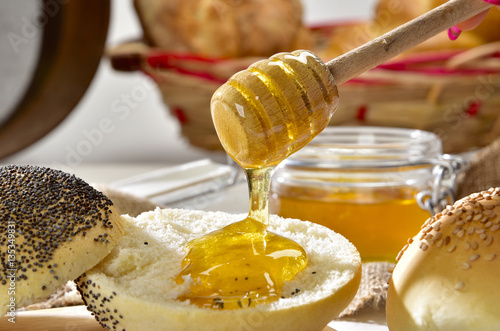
xmin=76 ymin=208 xmax=361 ymax=331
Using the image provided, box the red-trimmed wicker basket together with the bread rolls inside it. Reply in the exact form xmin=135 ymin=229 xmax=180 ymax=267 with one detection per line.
xmin=108 ymin=0 xmax=500 ymax=153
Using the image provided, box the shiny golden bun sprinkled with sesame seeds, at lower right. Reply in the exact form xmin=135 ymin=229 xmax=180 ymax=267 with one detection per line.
xmin=386 ymin=188 xmax=500 ymax=331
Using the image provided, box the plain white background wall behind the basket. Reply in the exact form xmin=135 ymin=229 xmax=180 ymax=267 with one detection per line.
xmin=0 ymin=0 xmax=374 ymax=168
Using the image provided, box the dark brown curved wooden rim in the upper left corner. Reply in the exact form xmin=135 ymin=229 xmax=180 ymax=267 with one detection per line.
xmin=0 ymin=0 xmax=110 ymax=158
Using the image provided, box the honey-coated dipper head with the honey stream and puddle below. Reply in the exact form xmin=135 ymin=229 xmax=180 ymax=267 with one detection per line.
xmin=176 ymin=52 xmax=338 ymax=309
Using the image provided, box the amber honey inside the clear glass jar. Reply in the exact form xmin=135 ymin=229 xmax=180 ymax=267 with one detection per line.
xmin=271 ymin=182 xmax=429 ymax=262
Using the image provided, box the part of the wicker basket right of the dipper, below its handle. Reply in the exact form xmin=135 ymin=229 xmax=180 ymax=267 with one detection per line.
xmin=332 ymin=42 xmax=500 ymax=153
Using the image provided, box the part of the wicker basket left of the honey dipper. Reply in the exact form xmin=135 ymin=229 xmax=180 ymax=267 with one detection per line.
xmin=108 ymin=43 xmax=261 ymax=150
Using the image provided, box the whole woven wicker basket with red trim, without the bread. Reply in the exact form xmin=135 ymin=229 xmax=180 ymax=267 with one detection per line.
xmin=111 ymin=43 xmax=500 ymax=153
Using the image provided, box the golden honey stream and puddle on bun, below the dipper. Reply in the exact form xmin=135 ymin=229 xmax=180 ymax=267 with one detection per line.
xmin=177 ymin=167 xmax=307 ymax=309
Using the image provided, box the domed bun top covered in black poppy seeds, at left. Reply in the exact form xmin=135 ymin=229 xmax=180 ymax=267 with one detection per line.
xmin=0 ymin=166 xmax=123 ymax=316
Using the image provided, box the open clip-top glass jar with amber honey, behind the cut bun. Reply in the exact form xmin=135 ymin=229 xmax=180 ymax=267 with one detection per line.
xmin=270 ymin=127 xmax=463 ymax=261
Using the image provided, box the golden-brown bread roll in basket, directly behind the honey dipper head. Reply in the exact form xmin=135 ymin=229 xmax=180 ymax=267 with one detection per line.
xmin=134 ymin=0 xmax=310 ymax=58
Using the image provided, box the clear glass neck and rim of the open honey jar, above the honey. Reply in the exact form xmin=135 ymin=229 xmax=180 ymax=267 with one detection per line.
xmin=283 ymin=126 xmax=442 ymax=169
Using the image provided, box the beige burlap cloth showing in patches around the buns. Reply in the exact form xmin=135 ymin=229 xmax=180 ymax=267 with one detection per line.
xmin=25 ymin=139 xmax=500 ymax=317
